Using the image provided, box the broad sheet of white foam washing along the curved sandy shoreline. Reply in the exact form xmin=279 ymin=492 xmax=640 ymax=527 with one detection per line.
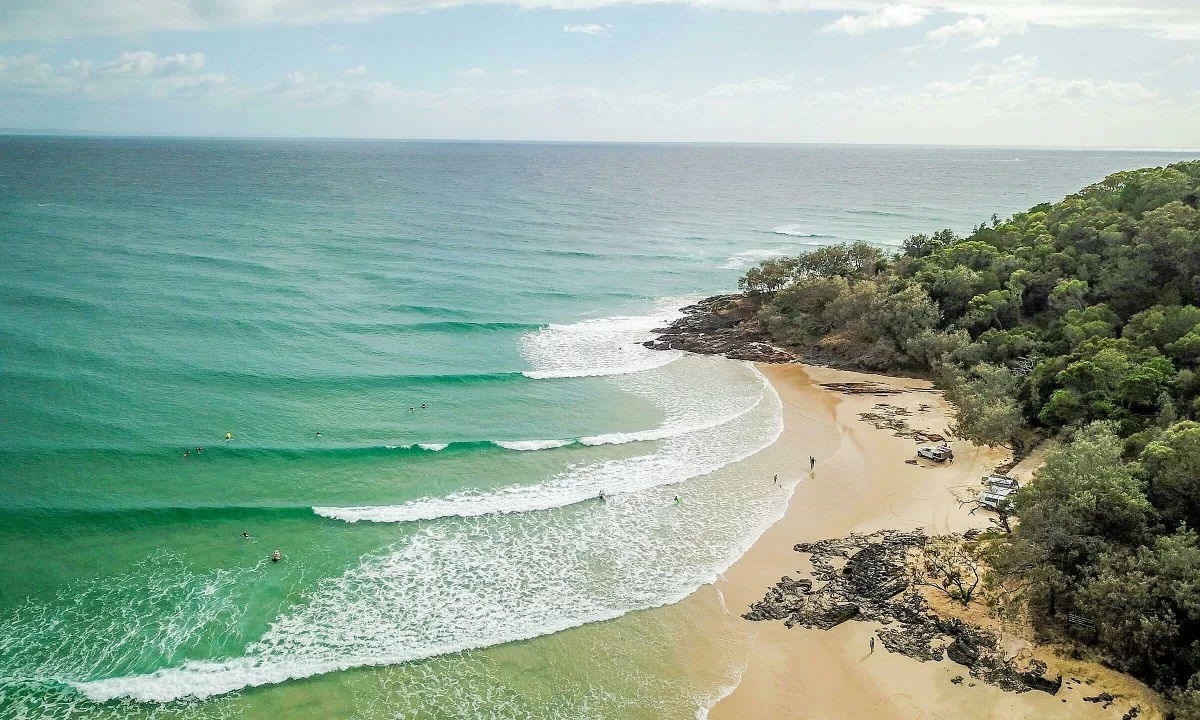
xmin=73 ymin=356 xmax=790 ymax=702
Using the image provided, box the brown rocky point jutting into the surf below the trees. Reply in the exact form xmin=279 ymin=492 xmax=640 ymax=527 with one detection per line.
xmin=642 ymin=295 xmax=796 ymax=362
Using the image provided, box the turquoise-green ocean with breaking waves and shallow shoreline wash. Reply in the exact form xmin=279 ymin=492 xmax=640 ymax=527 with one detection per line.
xmin=0 ymin=137 xmax=1194 ymax=719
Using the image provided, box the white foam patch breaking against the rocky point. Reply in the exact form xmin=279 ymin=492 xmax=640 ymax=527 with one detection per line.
xmin=521 ymin=301 xmax=683 ymax=379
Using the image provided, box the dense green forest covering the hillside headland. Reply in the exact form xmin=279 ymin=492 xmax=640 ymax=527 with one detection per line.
xmin=739 ymin=161 xmax=1200 ymax=720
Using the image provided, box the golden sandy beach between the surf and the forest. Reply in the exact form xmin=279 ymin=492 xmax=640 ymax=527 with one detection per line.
xmin=709 ymin=365 xmax=1153 ymax=720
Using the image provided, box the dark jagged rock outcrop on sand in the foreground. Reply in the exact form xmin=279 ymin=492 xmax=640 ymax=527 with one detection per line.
xmin=742 ymin=530 xmax=1062 ymax=695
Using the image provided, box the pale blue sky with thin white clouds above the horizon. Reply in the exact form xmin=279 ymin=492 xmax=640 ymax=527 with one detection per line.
xmin=0 ymin=0 xmax=1200 ymax=148
